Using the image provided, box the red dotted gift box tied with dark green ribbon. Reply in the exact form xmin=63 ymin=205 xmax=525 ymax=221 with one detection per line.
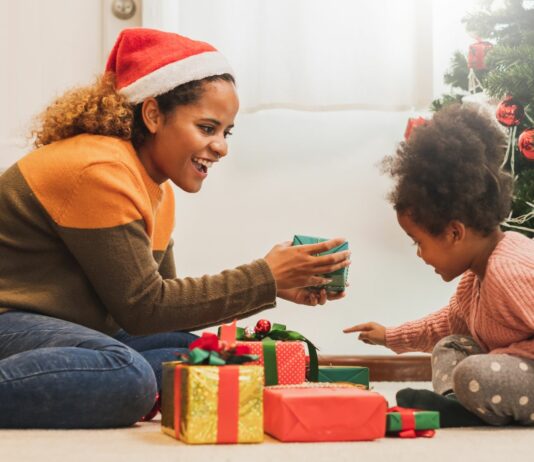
xmin=237 ymin=341 xmax=306 ymax=385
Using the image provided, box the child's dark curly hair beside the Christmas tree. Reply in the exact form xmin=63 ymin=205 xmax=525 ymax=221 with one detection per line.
xmin=382 ymin=104 xmax=512 ymax=236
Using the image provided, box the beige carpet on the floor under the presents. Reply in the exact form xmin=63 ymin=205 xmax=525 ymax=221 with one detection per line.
xmin=0 ymin=382 xmax=534 ymax=462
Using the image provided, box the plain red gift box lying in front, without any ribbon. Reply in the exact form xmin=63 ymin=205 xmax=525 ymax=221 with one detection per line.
xmin=263 ymin=384 xmax=387 ymax=442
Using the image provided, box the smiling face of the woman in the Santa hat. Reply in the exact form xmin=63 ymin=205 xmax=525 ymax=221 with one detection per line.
xmin=139 ymin=80 xmax=239 ymax=193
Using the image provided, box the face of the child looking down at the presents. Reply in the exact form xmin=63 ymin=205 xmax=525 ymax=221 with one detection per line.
xmin=397 ymin=213 xmax=469 ymax=282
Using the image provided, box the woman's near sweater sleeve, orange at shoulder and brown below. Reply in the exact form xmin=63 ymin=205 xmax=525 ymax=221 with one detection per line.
xmin=58 ymin=165 xmax=276 ymax=334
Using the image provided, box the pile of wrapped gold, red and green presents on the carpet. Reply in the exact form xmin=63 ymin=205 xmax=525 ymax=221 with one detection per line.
xmin=161 ymin=236 xmax=439 ymax=444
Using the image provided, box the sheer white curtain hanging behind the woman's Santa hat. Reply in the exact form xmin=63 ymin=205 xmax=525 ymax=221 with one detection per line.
xmin=143 ymin=0 xmax=478 ymax=112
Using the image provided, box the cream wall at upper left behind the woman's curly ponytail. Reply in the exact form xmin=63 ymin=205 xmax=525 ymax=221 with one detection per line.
xmin=0 ymin=0 xmax=141 ymax=169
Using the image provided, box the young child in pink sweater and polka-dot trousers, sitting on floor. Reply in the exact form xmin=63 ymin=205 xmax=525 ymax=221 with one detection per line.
xmin=344 ymin=106 xmax=534 ymax=427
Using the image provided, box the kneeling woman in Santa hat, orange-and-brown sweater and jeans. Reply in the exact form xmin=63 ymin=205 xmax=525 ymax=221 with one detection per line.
xmin=0 ymin=29 xmax=350 ymax=428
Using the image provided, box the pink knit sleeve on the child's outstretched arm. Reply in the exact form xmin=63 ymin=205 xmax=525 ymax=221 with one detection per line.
xmin=386 ymin=283 xmax=469 ymax=353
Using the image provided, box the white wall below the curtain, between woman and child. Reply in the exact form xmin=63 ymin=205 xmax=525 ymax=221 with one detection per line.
xmin=182 ymin=110 xmax=455 ymax=354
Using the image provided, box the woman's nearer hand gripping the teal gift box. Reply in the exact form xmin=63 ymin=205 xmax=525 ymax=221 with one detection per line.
xmin=265 ymin=239 xmax=350 ymax=291
